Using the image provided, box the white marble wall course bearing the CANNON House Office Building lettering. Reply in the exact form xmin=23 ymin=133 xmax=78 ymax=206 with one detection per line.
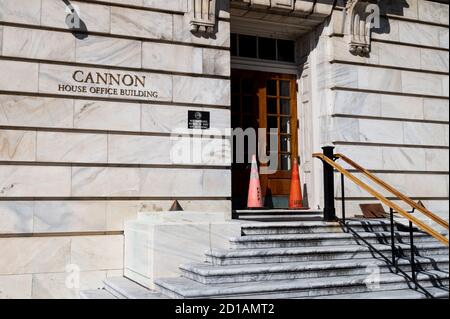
xmin=0 ymin=60 xmax=230 ymax=107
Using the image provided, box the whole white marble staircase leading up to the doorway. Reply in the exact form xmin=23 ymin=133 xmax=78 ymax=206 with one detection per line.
xmin=82 ymin=220 xmax=449 ymax=299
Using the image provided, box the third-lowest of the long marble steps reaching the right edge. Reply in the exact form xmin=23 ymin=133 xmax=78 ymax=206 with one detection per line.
xmin=205 ymin=243 xmax=449 ymax=265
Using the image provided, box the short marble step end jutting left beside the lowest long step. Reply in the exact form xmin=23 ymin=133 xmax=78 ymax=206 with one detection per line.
xmin=103 ymin=277 xmax=167 ymax=299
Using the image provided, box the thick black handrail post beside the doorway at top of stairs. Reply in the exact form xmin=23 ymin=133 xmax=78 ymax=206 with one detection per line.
xmin=322 ymin=146 xmax=336 ymax=221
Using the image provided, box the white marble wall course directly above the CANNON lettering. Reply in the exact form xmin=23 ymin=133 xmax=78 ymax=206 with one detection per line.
xmin=0 ymin=26 xmax=230 ymax=76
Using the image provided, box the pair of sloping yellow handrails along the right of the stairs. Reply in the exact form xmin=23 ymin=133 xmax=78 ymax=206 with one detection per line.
xmin=313 ymin=153 xmax=449 ymax=246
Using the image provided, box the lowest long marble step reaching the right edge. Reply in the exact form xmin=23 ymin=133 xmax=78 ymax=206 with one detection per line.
xmin=155 ymin=270 xmax=449 ymax=299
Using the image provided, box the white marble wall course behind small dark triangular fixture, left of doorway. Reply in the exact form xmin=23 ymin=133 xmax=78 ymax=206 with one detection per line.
xmin=0 ymin=200 xmax=231 ymax=234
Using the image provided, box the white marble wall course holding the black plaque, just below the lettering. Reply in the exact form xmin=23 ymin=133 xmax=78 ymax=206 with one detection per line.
xmin=0 ymin=95 xmax=231 ymax=135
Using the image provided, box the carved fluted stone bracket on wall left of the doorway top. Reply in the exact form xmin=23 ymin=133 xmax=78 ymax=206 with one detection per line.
xmin=190 ymin=0 xmax=217 ymax=36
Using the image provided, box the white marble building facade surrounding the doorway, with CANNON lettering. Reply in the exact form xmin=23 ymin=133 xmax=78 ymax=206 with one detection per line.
xmin=0 ymin=0 xmax=449 ymax=298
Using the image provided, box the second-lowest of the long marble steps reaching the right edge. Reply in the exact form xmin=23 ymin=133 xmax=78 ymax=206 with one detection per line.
xmin=180 ymin=256 xmax=449 ymax=284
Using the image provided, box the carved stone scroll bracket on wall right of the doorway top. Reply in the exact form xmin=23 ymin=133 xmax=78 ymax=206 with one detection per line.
xmin=345 ymin=0 xmax=379 ymax=56
